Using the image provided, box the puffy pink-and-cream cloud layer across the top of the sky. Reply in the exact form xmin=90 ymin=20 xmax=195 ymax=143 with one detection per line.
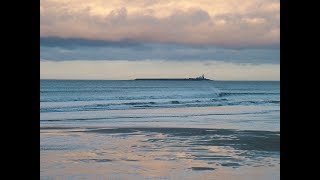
xmin=40 ymin=0 xmax=280 ymax=47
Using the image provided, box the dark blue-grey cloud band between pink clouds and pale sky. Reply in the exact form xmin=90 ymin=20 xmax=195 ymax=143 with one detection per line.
xmin=40 ymin=37 xmax=280 ymax=64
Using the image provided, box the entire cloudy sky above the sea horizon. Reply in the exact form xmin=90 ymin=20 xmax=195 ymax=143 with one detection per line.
xmin=40 ymin=0 xmax=280 ymax=80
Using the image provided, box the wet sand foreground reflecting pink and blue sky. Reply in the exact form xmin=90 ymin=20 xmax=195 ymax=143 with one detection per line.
xmin=41 ymin=127 xmax=280 ymax=179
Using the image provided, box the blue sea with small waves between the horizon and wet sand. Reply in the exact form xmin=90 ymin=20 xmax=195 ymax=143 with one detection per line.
xmin=40 ymin=80 xmax=280 ymax=131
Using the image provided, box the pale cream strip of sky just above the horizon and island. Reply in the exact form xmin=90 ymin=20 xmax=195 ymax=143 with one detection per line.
xmin=40 ymin=60 xmax=280 ymax=81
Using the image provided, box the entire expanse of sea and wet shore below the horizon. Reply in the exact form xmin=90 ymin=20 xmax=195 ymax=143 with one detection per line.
xmin=40 ymin=80 xmax=280 ymax=179
